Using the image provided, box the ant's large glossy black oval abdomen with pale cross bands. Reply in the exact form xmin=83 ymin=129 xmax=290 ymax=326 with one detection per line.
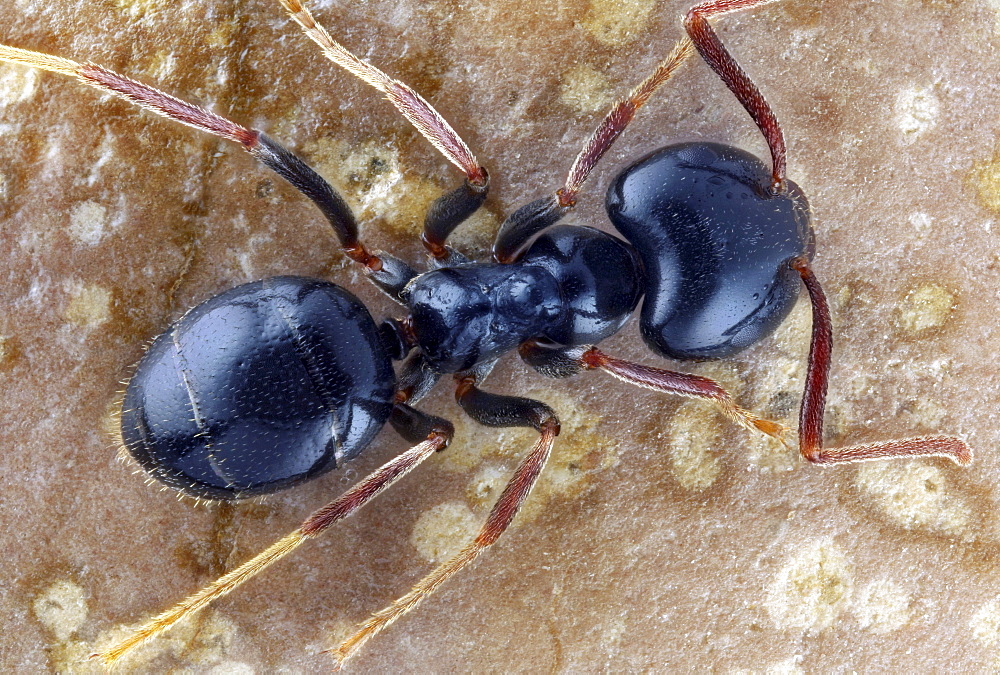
xmin=121 ymin=277 xmax=396 ymax=500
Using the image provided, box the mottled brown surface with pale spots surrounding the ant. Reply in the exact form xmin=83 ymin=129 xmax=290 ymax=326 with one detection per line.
xmin=0 ymin=0 xmax=1000 ymax=672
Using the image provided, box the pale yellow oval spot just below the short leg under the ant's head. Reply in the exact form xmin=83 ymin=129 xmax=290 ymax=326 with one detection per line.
xmin=667 ymin=401 xmax=722 ymax=490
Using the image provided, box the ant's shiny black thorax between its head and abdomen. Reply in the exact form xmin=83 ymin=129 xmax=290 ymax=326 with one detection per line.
xmin=403 ymin=225 xmax=642 ymax=373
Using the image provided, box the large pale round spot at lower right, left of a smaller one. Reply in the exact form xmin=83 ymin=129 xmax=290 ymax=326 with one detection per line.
xmin=765 ymin=539 xmax=853 ymax=631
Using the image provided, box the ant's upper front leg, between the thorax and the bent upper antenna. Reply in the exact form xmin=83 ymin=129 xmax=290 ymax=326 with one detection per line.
xmin=493 ymin=38 xmax=693 ymax=263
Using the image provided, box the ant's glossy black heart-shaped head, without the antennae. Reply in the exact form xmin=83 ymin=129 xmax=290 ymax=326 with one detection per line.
xmin=606 ymin=143 xmax=814 ymax=359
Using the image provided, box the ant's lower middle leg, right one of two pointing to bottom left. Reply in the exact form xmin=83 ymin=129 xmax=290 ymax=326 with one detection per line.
xmin=333 ymin=374 xmax=559 ymax=669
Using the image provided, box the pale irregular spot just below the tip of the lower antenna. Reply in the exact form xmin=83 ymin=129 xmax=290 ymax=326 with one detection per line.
xmin=854 ymin=462 xmax=972 ymax=537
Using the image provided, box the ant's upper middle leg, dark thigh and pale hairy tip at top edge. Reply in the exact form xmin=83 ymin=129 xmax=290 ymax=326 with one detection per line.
xmin=280 ymin=0 xmax=489 ymax=261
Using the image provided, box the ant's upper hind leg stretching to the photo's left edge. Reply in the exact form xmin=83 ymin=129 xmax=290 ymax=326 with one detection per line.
xmin=0 ymin=45 xmax=393 ymax=274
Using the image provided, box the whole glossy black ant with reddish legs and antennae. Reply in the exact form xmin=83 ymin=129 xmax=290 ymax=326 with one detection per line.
xmin=0 ymin=0 xmax=971 ymax=665
